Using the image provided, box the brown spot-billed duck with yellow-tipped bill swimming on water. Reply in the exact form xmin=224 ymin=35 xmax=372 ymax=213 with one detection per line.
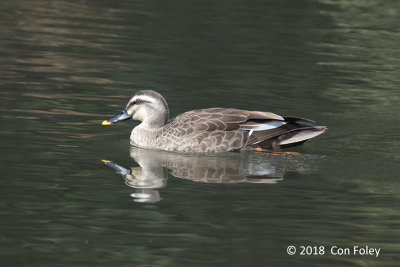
xmin=102 ymin=90 xmax=327 ymax=153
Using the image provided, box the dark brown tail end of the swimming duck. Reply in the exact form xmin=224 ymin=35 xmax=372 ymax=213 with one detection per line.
xmin=244 ymin=117 xmax=327 ymax=149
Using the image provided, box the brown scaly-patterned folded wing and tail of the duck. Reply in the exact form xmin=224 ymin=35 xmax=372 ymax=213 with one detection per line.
xmin=170 ymin=108 xmax=326 ymax=149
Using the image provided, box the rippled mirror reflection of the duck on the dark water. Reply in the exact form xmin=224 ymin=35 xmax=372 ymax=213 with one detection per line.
xmin=102 ymin=147 xmax=315 ymax=202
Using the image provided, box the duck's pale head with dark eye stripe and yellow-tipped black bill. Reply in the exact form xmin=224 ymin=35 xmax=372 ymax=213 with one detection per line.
xmin=102 ymin=90 xmax=169 ymax=128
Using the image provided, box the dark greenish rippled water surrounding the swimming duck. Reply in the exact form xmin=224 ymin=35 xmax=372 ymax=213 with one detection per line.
xmin=0 ymin=0 xmax=400 ymax=266
